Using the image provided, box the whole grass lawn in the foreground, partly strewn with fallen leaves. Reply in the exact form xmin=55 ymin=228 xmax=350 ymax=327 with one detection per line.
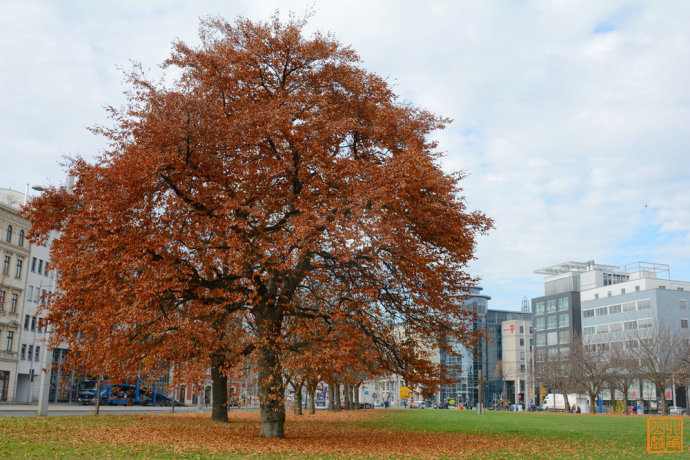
xmin=0 ymin=409 xmax=690 ymax=459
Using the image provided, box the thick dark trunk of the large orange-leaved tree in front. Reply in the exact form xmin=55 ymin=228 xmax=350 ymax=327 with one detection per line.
xmin=254 ymin=307 xmax=285 ymax=438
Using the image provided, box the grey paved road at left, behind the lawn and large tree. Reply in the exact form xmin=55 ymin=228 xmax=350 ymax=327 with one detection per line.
xmin=0 ymin=404 xmax=211 ymax=417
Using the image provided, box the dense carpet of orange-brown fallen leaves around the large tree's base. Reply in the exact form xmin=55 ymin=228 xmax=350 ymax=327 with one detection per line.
xmin=74 ymin=411 xmax=604 ymax=458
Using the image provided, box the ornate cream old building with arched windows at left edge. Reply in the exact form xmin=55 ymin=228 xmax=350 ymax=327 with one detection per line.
xmin=0 ymin=189 xmax=31 ymax=402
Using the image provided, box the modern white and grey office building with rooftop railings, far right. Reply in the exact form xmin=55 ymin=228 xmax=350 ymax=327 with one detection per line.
xmin=532 ymin=261 xmax=690 ymax=405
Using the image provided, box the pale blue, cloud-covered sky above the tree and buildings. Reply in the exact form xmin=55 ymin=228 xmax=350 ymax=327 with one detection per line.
xmin=0 ymin=0 xmax=690 ymax=309
